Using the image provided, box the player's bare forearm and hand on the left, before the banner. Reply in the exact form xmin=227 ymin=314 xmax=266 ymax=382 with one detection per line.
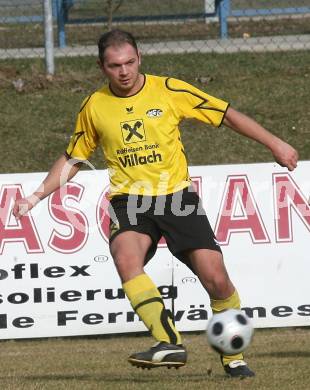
xmin=13 ymin=155 xmax=80 ymax=219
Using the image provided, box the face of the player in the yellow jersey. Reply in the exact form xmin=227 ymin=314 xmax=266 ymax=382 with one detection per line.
xmin=101 ymin=43 xmax=144 ymax=96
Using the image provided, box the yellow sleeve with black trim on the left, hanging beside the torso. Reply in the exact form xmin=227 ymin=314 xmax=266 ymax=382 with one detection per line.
xmin=66 ymin=96 xmax=98 ymax=160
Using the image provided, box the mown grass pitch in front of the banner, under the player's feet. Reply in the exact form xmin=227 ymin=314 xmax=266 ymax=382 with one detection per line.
xmin=0 ymin=328 xmax=310 ymax=390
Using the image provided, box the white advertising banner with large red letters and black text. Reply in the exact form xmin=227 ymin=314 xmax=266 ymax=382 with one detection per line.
xmin=0 ymin=161 xmax=310 ymax=339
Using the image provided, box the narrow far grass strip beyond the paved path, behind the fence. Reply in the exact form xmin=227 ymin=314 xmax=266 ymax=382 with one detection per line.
xmin=0 ymin=15 xmax=310 ymax=49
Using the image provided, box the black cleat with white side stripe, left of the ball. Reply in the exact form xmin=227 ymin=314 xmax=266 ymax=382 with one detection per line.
xmin=128 ymin=341 xmax=187 ymax=369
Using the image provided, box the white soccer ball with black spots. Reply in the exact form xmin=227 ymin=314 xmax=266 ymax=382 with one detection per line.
xmin=207 ymin=309 xmax=254 ymax=355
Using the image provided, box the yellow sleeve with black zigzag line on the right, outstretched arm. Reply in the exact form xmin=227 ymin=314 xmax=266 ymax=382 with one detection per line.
xmin=166 ymin=78 xmax=229 ymax=127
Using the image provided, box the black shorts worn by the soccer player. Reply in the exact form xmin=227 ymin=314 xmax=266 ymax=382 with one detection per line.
xmin=109 ymin=187 xmax=221 ymax=266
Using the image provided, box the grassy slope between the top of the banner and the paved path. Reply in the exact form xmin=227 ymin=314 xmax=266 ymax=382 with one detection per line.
xmin=0 ymin=51 xmax=310 ymax=173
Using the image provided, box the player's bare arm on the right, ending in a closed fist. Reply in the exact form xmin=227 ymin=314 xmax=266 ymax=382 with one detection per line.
xmin=223 ymin=107 xmax=298 ymax=171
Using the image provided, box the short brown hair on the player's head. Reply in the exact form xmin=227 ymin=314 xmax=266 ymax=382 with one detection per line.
xmin=98 ymin=29 xmax=138 ymax=63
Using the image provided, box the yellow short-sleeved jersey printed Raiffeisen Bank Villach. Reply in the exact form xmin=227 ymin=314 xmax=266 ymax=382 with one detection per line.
xmin=66 ymin=74 xmax=228 ymax=197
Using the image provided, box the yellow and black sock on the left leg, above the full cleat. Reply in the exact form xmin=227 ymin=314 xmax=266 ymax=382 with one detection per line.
xmin=123 ymin=274 xmax=182 ymax=344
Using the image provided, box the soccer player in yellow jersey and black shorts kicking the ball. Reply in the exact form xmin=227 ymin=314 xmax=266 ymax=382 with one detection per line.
xmin=13 ymin=30 xmax=298 ymax=377
